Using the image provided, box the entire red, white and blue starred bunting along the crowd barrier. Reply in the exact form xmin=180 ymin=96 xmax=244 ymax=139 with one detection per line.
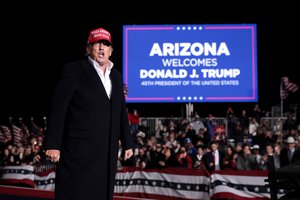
xmin=0 ymin=165 xmax=287 ymax=200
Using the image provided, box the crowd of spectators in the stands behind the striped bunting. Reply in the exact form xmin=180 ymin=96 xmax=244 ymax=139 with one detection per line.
xmin=0 ymin=104 xmax=300 ymax=171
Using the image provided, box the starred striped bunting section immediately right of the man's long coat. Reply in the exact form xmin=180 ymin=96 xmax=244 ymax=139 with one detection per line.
xmin=114 ymin=168 xmax=210 ymax=200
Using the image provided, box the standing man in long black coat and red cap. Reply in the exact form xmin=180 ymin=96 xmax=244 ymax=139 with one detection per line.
xmin=44 ymin=28 xmax=134 ymax=200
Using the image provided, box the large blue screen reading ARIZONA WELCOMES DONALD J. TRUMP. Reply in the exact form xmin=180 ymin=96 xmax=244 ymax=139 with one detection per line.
xmin=123 ymin=24 xmax=258 ymax=103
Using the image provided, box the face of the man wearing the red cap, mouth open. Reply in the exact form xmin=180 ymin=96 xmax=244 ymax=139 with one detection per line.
xmin=87 ymin=40 xmax=112 ymax=65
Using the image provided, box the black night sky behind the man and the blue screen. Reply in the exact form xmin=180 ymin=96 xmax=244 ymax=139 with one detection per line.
xmin=0 ymin=9 xmax=300 ymax=119
